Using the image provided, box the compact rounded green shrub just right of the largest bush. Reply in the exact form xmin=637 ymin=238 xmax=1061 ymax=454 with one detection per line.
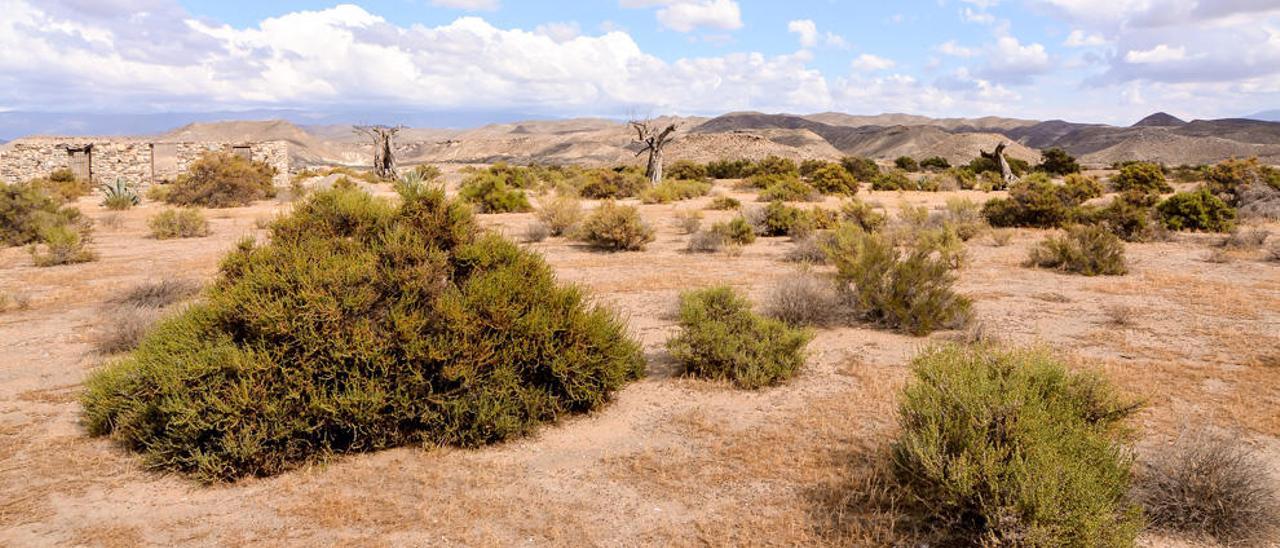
xmin=667 ymin=287 xmax=813 ymax=389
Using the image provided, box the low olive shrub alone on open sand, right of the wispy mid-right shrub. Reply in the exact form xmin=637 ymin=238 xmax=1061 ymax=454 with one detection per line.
xmin=1028 ymin=225 xmax=1129 ymax=277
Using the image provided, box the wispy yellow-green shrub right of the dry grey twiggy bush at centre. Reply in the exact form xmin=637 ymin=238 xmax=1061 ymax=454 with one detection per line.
xmin=827 ymin=224 xmax=972 ymax=335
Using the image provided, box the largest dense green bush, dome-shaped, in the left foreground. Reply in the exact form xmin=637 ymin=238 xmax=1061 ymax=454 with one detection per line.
xmin=83 ymin=188 xmax=644 ymax=481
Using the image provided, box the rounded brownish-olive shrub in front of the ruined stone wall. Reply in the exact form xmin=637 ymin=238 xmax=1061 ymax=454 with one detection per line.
xmin=165 ymin=152 xmax=275 ymax=207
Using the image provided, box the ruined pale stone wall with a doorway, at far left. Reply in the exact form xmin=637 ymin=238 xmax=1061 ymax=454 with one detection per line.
xmin=0 ymin=137 xmax=289 ymax=188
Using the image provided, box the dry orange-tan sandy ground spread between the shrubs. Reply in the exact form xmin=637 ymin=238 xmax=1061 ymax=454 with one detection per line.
xmin=0 ymin=170 xmax=1280 ymax=545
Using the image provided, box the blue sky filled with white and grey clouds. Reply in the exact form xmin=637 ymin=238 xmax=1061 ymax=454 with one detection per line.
xmin=0 ymin=0 xmax=1280 ymax=124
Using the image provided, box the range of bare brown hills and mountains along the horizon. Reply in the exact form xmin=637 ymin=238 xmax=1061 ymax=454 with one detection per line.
xmin=0 ymin=111 xmax=1280 ymax=166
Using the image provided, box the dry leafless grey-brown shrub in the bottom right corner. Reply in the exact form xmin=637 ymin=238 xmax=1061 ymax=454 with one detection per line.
xmin=1137 ymin=431 xmax=1280 ymax=545
